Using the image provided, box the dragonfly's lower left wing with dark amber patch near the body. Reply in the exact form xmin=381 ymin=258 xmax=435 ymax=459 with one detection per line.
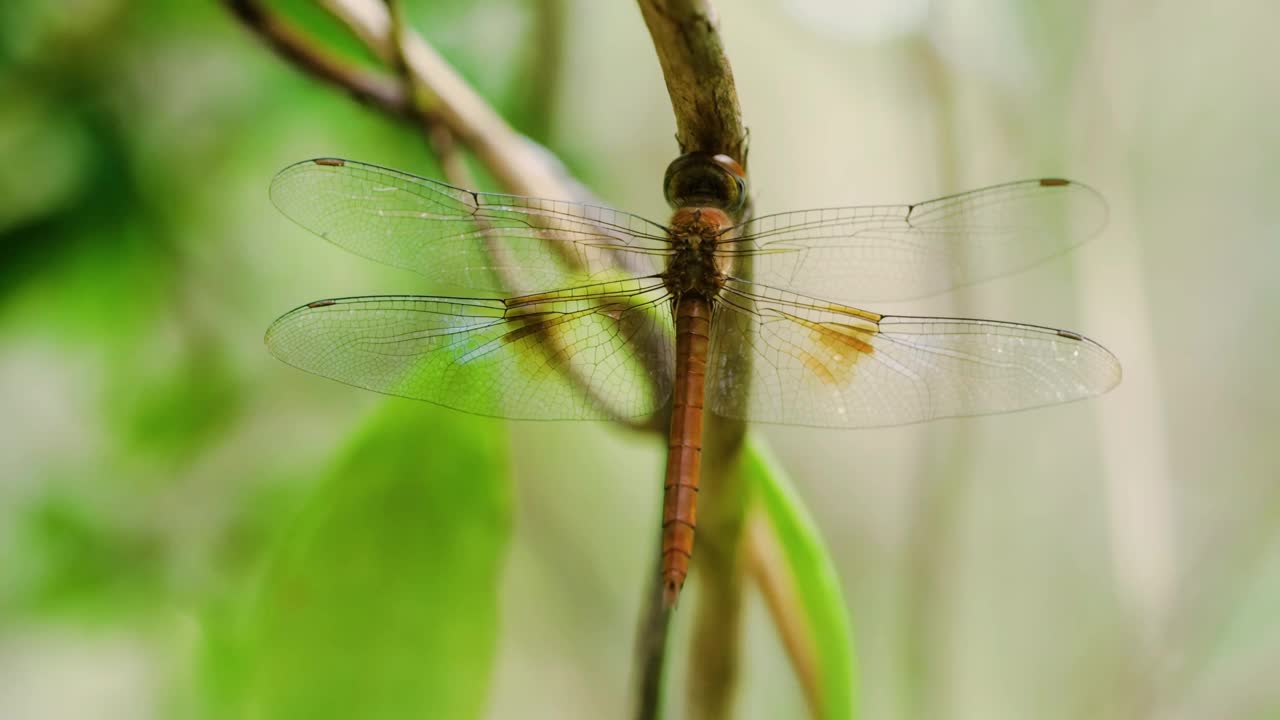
xmin=266 ymin=278 xmax=673 ymax=420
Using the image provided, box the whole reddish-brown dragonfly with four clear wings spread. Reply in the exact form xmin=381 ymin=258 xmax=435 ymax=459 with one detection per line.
xmin=266 ymin=152 xmax=1121 ymax=607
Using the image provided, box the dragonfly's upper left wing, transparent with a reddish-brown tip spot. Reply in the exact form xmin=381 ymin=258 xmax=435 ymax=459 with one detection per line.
xmin=271 ymin=159 xmax=668 ymax=295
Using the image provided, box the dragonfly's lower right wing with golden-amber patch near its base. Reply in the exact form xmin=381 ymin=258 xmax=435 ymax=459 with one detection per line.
xmin=707 ymin=281 xmax=1120 ymax=428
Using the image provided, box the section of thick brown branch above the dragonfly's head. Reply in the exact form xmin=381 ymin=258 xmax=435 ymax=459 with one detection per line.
xmin=639 ymin=0 xmax=746 ymax=162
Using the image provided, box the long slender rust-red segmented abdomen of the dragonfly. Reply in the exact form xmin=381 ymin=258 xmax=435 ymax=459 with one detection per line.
xmin=662 ymin=295 xmax=710 ymax=607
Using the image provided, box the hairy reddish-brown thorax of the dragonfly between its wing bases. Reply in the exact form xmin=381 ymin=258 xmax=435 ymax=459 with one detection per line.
xmin=663 ymin=208 xmax=732 ymax=297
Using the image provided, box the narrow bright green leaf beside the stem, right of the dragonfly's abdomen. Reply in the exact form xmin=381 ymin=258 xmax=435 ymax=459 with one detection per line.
xmin=742 ymin=437 xmax=856 ymax=720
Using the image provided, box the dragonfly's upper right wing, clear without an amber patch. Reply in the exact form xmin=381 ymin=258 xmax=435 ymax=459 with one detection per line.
xmin=723 ymin=179 xmax=1107 ymax=302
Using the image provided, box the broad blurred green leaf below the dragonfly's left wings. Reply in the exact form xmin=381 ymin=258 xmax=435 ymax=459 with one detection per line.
xmin=247 ymin=401 xmax=511 ymax=720
